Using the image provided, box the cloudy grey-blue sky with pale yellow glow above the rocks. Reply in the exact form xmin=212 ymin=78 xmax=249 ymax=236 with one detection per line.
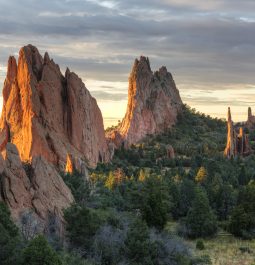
xmin=0 ymin=0 xmax=255 ymax=127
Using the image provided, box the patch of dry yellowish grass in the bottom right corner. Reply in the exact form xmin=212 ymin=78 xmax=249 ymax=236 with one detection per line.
xmin=165 ymin=223 xmax=255 ymax=265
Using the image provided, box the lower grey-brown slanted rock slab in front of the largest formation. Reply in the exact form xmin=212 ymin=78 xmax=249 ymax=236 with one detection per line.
xmin=0 ymin=143 xmax=74 ymax=230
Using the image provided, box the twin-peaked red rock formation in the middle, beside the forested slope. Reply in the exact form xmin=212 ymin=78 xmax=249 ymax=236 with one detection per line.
xmin=107 ymin=56 xmax=182 ymax=147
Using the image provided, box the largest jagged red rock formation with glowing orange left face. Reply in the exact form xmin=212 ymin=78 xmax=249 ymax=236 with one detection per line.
xmin=0 ymin=45 xmax=110 ymax=171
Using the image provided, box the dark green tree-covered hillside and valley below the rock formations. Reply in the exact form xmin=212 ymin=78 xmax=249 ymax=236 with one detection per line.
xmin=1 ymin=106 xmax=255 ymax=265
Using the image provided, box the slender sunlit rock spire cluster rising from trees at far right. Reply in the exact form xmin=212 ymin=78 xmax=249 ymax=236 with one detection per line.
xmin=224 ymin=108 xmax=252 ymax=158
